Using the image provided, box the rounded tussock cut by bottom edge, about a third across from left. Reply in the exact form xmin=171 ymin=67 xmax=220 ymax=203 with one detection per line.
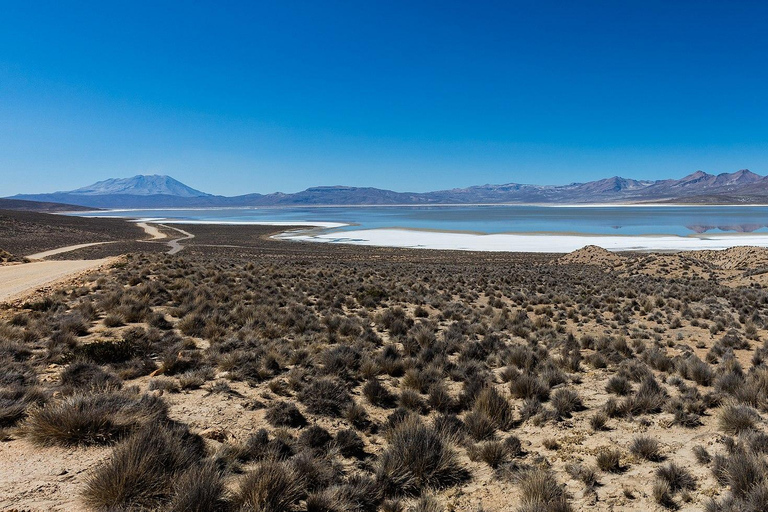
xmin=234 ymin=462 xmax=306 ymax=512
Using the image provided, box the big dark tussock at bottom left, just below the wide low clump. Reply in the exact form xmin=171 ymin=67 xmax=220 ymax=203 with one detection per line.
xmin=83 ymin=424 xmax=206 ymax=511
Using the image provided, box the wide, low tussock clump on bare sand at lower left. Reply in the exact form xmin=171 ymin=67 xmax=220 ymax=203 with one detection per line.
xmin=24 ymin=393 xmax=168 ymax=446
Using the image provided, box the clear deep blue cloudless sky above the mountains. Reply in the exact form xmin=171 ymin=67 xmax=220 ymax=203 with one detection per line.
xmin=0 ymin=0 xmax=768 ymax=195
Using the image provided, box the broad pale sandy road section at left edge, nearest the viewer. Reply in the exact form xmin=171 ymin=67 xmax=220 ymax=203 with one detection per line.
xmin=0 ymin=258 xmax=114 ymax=302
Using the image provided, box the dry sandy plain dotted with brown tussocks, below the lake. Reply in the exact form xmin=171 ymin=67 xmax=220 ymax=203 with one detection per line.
xmin=0 ymin=214 xmax=768 ymax=512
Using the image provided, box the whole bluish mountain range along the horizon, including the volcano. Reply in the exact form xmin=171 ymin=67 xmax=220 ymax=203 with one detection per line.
xmin=9 ymin=169 xmax=768 ymax=208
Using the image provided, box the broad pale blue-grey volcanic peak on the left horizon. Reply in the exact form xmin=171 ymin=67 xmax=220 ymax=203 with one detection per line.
xmin=64 ymin=174 xmax=210 ymax=197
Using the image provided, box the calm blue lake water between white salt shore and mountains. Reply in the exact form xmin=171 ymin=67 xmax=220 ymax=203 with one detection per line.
xmin=73 ymin=205 xmax=768 ymax=236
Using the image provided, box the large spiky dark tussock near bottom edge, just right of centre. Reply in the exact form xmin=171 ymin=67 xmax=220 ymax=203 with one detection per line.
xmin=376 ymin=416 xmax=469 ymax=496
